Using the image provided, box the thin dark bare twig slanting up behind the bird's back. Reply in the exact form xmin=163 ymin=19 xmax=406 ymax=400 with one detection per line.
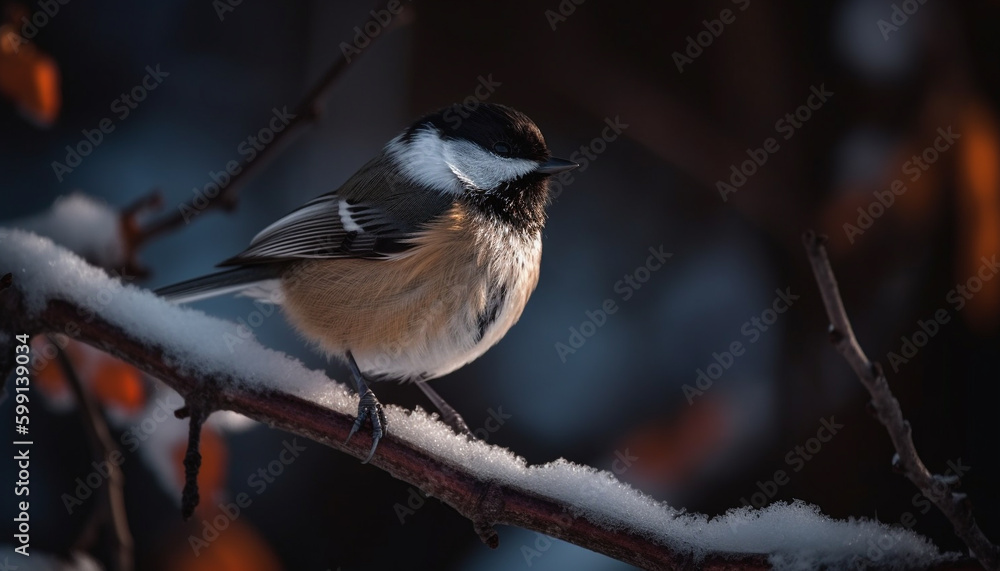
xmin=133 ymin=0 xmax=410 ymax=248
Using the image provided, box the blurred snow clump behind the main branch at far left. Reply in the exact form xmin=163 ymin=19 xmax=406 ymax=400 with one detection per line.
xmin=4 ymin=192 xmax=125 ymax=268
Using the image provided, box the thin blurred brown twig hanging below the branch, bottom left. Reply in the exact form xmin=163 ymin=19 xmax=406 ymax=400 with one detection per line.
xmin=49 ymin=340 xmax=134 ymax=571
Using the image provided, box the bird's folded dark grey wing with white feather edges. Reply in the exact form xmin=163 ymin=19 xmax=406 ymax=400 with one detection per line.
xmin=219 ymin=155 xmax=453 ymax=266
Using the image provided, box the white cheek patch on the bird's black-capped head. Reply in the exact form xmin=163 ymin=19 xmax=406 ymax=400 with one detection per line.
xmin=384 ymin=130 xmax=538 ymax=194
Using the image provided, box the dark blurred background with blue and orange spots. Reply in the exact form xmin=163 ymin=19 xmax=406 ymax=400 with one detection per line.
xmin=0 ymin=0 xmax=1000 ymax=571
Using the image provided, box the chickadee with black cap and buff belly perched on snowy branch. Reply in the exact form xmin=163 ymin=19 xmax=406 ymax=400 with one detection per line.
xmin=157 ymin=103 xmax=578 ymax=462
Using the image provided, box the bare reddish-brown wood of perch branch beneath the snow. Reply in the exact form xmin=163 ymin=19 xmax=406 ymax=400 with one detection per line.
xmin=2 ymin=290 xmax=752 ymax=569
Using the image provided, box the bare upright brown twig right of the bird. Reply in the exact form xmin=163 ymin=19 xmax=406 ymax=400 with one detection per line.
xmin=802 ymin=231 xmax=1000 ymax=569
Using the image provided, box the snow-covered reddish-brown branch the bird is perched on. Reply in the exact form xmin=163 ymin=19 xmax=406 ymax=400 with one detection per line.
xmin=0 ymin=229 xmax=956 ymax=569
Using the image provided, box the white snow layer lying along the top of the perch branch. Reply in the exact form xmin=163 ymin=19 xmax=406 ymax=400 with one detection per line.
xmin=0 ymin=230 xmax=952 ymax=569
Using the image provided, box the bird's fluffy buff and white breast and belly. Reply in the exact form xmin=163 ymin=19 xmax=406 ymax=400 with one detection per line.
xmin=282 ymin=205 xmax=541 ymax=379
